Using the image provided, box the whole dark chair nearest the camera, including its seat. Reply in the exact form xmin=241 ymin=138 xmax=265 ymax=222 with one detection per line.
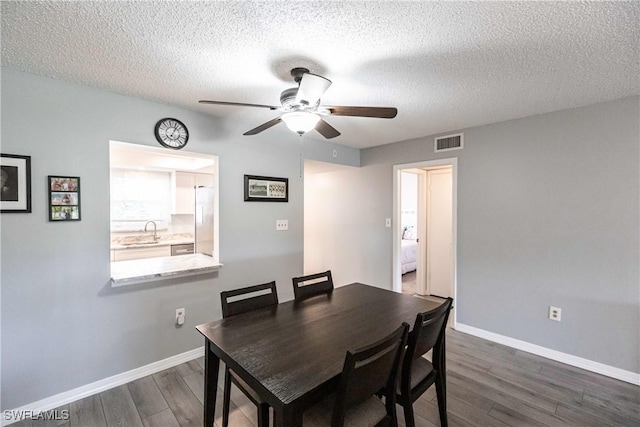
xmin=302 ymin=323 xmax=409 ymax=427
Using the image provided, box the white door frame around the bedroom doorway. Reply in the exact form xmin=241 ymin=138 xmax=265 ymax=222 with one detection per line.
xmin=392 ymin=157 xmax=458 ymax=328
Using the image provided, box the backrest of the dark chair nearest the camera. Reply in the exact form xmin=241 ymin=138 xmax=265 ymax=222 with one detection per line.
xmin=331 ymin=323 xmax=409 ymax=427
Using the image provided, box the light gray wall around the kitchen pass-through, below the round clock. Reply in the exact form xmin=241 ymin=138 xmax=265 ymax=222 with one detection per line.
xmin=0 ymin=68 xmax=360 ymax=410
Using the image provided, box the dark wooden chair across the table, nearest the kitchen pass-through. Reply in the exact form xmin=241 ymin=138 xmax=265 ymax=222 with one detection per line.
xmin=220 ymin=281 xmax=278 ymax=427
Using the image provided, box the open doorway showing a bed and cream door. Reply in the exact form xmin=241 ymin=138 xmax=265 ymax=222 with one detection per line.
xmin=393 ymin=159 xmax=457 ymax=310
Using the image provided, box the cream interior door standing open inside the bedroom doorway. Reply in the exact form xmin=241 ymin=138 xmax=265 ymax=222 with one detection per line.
xmin=426 ymin=168 xmax=453 ymax=297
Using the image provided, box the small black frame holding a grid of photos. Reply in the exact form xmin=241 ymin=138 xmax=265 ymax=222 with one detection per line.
xmin=48 ymin=175 xmax=80 ymax=221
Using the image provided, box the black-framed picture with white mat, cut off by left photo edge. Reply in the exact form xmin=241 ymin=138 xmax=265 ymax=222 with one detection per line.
xmin=0 ymin=154 xmax=31 ymax=213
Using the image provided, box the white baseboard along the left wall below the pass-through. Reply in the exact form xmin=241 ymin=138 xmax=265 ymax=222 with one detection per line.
xmin=2 ymin=346 xmax=204 ymax=426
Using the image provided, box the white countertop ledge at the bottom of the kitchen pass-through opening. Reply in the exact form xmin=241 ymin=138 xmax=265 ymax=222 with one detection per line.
xmin=111 ymin=254 xmax=222 ymax=287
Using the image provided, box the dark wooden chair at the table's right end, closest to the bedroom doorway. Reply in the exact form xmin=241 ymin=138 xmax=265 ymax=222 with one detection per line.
xmin=396 ymin=298 xmax=453 ymax=427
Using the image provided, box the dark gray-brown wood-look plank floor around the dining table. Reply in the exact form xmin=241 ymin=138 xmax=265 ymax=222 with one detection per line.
xmin=13 ymin=330 xmax=640 ymax=427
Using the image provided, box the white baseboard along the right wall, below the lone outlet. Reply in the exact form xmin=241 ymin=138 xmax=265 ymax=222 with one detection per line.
xmin=455 ymin=323 xmax=640 ymax=385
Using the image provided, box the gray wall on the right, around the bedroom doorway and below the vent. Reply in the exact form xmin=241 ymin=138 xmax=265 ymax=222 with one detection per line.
xmin=317 ymin=97 xmax=640 ymax=372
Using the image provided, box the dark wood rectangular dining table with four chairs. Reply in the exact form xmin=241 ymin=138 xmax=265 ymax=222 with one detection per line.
xmin=197 ymin=283 xmax=439 ymax=427
